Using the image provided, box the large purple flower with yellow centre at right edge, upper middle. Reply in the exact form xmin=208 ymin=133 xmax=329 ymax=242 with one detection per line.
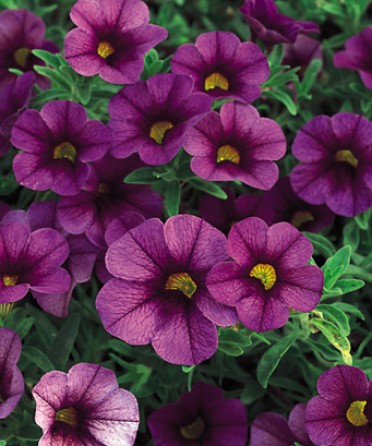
xmin=290 ymin=113 xmax=372 ymax=217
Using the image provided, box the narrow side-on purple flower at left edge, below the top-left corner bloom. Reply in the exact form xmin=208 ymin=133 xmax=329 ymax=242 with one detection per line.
xmin=0 ymin=72 xmax=35 ymax=156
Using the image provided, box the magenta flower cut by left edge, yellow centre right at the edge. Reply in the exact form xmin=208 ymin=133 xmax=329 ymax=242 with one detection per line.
xmin=0 ymin=222 xmax=70 ymax=303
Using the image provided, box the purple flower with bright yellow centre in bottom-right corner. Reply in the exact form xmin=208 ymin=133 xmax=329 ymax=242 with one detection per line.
xmin=306 ymin=365 xmax=372 ymax=446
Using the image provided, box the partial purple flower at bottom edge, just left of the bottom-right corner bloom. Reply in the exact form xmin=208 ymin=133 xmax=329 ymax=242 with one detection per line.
xmin=249 ymin=404 xmax=313 ymax=446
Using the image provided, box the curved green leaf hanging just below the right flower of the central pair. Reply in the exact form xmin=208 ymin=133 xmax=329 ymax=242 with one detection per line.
xmin=257 ymin=331 xmax=301 ymax=389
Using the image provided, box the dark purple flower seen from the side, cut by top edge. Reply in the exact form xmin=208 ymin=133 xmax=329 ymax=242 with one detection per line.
xmin=240 ymin=0 xmax=319 ymax=45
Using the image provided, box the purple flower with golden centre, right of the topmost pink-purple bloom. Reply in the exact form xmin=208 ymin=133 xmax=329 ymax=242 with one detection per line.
xmin=171 ymin=31 xmax=270 ymax=102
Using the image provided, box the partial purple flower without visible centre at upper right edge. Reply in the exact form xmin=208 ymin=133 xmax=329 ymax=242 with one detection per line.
xmin=333 ymin=26 xmax=372 ymax=89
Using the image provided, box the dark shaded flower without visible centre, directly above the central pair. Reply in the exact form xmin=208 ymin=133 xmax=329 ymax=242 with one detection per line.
xmin=199 ymin=189 xmax=260 ymax=232
